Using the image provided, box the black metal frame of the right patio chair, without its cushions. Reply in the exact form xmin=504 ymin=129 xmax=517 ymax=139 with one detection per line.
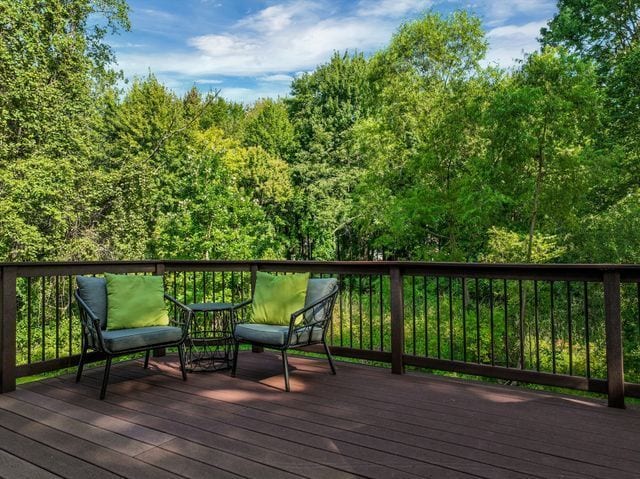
xmin=231 ymin=285 xmax=338 ymax=392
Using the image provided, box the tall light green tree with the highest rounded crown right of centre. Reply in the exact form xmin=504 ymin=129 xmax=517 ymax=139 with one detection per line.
xmin=355 ymin=12 xmax=491 ymax=259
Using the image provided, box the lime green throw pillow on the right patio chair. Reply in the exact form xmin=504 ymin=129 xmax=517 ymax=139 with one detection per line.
xmin=253 ymin=271 xmax=309 ymax=326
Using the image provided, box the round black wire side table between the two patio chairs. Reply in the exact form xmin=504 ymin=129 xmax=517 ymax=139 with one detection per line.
xmin=185 ymin=303 xmax=237 ymax=372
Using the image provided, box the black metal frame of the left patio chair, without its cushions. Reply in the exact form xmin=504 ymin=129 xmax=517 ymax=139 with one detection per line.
xmin=75 ymin=290 xmax=193 ymax=399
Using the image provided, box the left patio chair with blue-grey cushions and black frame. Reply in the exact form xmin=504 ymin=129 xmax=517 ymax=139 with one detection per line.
xmin=75 ymin=276 xmax=193 ymax=399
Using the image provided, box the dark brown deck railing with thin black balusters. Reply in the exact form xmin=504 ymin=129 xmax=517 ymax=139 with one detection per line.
xmin=0 ymin=261 xmax=640 ymax=407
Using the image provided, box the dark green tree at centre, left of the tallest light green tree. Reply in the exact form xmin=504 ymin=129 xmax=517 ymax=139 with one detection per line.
xmin=287 ymin=53 xmax=368 ymax=259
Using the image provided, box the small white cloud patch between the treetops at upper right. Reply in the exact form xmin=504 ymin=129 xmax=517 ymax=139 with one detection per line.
xmin=485 ymin=22 xmax=545 ymax=67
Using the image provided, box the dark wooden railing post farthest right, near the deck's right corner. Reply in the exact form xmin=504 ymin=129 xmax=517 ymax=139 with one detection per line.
xmin=603 ymin=271 xmax=624 ymax=408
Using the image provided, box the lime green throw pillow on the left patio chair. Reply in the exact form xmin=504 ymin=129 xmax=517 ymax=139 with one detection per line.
xmin=104 ymin=273 xmax=169 ymax=330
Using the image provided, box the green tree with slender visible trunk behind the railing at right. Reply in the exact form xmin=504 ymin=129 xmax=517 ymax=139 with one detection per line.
xmin=486 ymin=48 xmax=602 ymax=262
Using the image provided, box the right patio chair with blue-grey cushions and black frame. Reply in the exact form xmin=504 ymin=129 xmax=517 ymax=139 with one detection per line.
xmin=231 ymin=278 xmax=338 ymax=391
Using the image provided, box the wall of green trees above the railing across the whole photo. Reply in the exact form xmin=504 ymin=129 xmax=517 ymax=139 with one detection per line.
xmin=0 ymin=0 xmax=640 ymax=268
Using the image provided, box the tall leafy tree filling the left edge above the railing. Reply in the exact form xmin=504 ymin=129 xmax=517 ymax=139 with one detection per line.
xmin=0 ymin=0 xmax=128 ymax=261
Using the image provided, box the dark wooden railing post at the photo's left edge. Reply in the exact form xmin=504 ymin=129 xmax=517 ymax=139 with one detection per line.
xmin=0 ymin=266 xmax=17 ymax=393
